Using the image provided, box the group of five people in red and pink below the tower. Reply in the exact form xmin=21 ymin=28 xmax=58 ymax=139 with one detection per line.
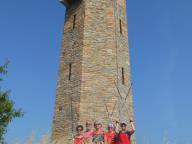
xmin=73 ymin=120 xmax=135 ymax=144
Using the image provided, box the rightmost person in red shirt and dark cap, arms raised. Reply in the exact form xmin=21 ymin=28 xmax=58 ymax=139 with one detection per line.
xmin=115 ymin=120 xmax=135 ymax=144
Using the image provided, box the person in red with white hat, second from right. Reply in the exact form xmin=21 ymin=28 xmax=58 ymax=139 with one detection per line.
xmin=105 ymin=124 xmax=117 ymax=144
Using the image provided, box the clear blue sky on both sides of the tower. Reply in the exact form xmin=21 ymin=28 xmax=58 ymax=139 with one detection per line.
xmin=0 ymin=0 xmax=192 ymax=144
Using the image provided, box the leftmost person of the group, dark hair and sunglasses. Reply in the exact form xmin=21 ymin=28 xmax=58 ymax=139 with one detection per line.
xmin=73 ymin=125 xmax=85 ymax=144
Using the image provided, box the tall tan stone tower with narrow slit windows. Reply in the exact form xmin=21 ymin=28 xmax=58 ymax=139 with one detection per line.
xmin=52 ymin=0 xmax=134 ymax=144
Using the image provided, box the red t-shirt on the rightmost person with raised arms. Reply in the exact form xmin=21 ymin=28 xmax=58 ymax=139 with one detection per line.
xmin=118 ymin=131 xmax=134 ymax=144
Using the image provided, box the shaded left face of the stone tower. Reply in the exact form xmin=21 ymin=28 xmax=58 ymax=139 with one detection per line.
xmin=52 ymin=3 xmax=84 ymax=144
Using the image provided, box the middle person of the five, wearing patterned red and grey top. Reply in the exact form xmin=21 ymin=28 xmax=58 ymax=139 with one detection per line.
xmin=93 ymin=121 xmax=104 ymax=144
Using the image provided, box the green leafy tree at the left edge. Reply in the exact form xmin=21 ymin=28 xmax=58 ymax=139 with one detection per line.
xmin=0 ymin=61 xmax=23 ymax=144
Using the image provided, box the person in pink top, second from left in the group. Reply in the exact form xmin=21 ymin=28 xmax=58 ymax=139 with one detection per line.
xmin=84 ymin=121 xmax=93 ymax=144
